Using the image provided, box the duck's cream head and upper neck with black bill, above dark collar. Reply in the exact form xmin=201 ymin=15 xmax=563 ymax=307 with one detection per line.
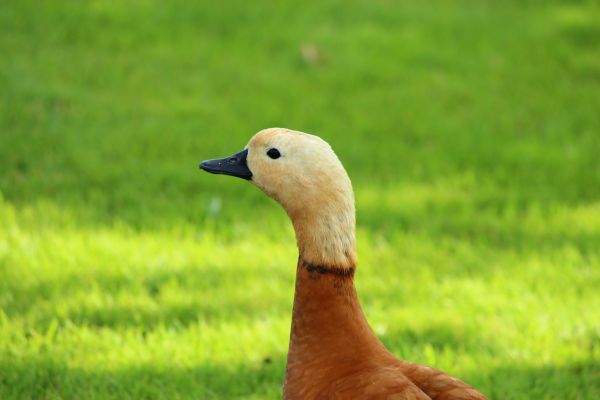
xmin=200 ymin=128 xmax=356 ymax=268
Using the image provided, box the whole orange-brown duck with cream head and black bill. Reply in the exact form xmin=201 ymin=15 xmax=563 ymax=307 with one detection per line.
xmin=200 ymin=128 xmax=485 ymax=400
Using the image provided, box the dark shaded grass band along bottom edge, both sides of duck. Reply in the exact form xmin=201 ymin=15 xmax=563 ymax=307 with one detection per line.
xmin=0 ymin=356 xmax=600 ymax=400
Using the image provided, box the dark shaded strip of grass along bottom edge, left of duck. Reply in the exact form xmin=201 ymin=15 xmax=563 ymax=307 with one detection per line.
xmin=0 ymin=356 xmax=285 ymax=400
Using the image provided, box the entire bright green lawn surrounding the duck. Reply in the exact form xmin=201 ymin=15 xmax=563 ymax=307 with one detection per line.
xmin=0 ymin=0 xmax=600 ymax=399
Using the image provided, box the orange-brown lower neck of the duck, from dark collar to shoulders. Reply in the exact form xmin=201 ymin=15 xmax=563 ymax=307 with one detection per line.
xmin=285 ymin=255 xmax=388 ymax=391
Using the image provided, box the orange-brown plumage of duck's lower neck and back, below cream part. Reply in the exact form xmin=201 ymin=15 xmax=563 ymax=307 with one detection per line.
xmin=284 ymin=259 xmax=485 ymax=400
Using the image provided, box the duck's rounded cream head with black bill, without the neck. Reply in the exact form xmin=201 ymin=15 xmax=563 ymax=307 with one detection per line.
xmin=200 ymin=128 xmax=354 ymax=215
